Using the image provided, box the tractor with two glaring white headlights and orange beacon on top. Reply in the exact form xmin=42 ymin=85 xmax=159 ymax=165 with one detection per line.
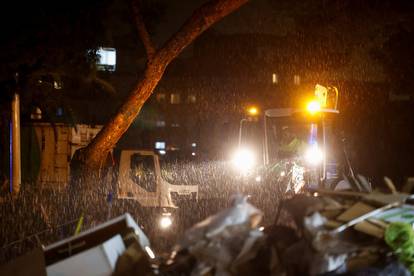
xmin=233 ymin=85 xmax=340 ymax=193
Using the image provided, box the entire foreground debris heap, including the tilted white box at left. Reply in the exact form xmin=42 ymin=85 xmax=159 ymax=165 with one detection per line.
xmin=0 ymin=190 xmax=414 ymax=276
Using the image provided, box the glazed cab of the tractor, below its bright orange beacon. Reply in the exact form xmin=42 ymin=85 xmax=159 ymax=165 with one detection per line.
xmin=264 ymin=104 xmax=339 ymax=192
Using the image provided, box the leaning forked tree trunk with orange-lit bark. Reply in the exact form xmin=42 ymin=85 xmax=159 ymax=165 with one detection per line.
xmin=80 ymin=0 xmax=248 ymax=172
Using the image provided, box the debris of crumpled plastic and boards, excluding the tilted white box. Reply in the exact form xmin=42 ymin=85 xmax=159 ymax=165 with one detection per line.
xmin=160 ymin=190 xmax=414 ymax=275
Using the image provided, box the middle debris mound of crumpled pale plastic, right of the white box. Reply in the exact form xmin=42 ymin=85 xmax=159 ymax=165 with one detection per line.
xmin=160 ymin=196 xmax=265 ymax=275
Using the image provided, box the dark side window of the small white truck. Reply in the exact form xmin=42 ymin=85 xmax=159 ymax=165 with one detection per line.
xmin=131 ymin=153 xmax=157 ymax=192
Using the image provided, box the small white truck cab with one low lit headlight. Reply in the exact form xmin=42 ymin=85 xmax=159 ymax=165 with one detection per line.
xmin=114 ymin=149 xmax=198 ymax=239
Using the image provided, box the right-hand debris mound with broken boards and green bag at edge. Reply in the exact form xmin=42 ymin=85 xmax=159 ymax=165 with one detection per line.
xmin=267 ymin=190 xmax=414 ymax=275
